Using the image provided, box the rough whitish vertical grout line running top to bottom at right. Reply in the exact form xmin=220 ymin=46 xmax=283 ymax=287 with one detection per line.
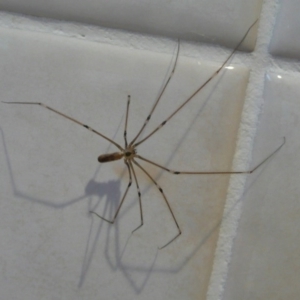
xmin=207 ymin=0 xmax=279 ymax=300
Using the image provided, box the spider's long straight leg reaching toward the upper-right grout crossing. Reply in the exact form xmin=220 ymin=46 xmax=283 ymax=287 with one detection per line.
xmin=134 ymin=19 xmax=258 ymax=147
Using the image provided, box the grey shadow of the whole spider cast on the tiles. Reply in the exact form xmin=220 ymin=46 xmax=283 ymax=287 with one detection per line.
xmin=0 ymin=95 xmax=269 ymax=294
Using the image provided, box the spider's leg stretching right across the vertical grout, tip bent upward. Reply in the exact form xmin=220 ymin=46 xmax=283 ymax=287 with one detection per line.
xmin=135 ymin=137 xmax=285 ymax=175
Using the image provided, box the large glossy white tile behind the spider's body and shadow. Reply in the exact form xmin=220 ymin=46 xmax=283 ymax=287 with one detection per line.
xmin=0 ymin=29 xmax=249 ymax=300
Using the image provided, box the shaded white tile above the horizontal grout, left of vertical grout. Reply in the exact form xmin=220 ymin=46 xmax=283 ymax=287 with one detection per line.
xmin=1 ymin=0 xmax=262 ymax=50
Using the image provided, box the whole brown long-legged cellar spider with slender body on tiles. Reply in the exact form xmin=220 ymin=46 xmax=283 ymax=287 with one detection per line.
xmin=2 ymin=20 xmax=285 ymax=249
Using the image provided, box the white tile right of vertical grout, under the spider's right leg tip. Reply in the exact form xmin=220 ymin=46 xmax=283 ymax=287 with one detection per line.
xmin=224 ymin=71 xmax=300 ymax=300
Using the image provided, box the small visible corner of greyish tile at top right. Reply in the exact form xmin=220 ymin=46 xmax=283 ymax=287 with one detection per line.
xmin=270 ymin=0 xmax=300 ymax=59
